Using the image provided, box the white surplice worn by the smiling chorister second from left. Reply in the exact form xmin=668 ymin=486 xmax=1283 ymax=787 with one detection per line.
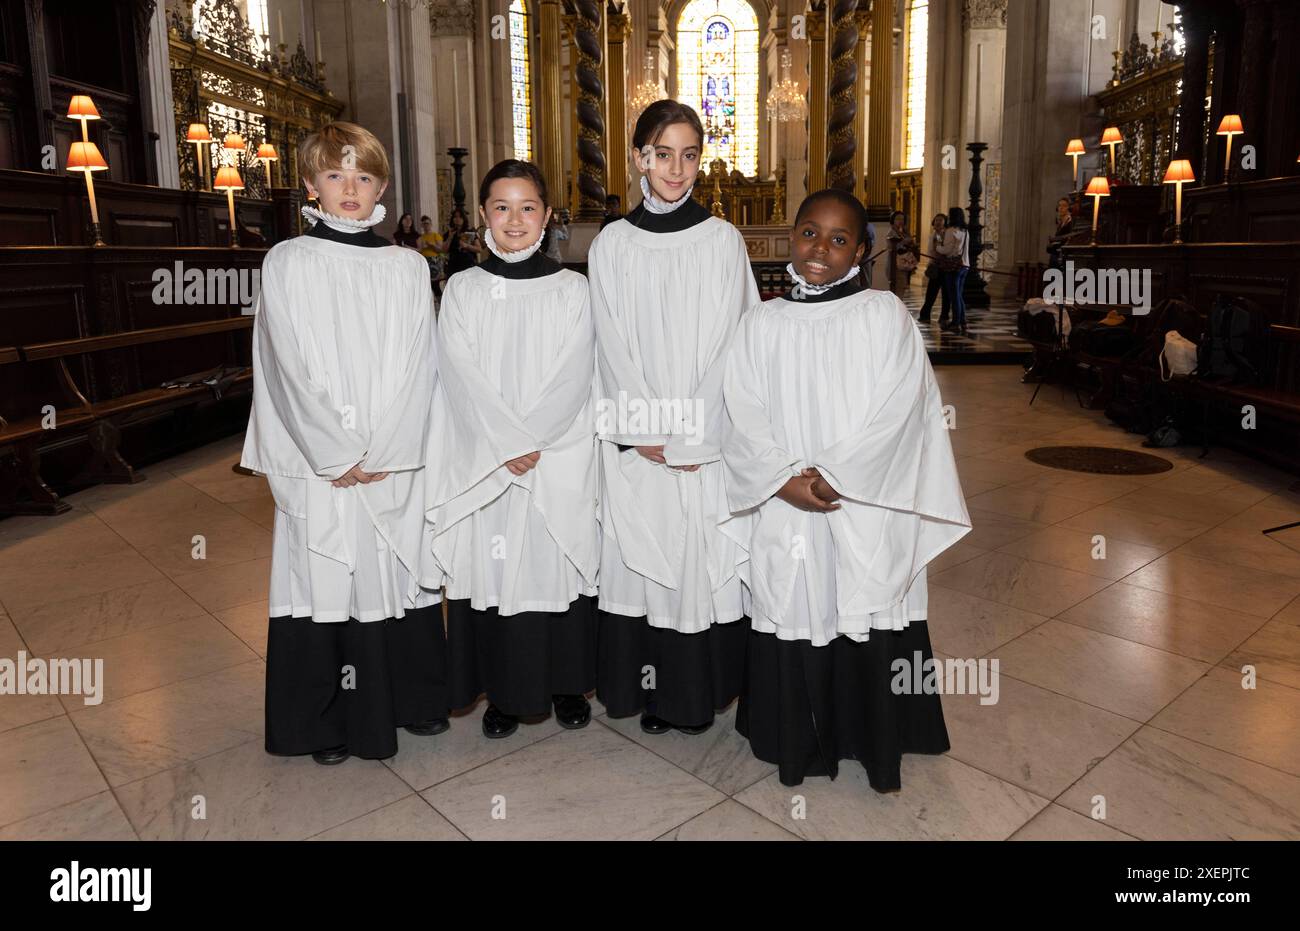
xmin=425 ymin=268 xmax=599 ymax=615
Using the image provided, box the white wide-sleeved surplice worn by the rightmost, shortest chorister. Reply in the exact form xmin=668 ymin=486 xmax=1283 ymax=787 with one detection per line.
xmin=723 ymin=290 xmax=971 ymax=646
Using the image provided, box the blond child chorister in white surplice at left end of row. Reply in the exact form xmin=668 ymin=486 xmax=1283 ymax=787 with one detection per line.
xmin=242 ymin=122 xmax=447 ymax=765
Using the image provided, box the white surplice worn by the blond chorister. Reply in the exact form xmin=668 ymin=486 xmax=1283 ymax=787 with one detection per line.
xmin=241 ymin=235 xmax=439 ymax=622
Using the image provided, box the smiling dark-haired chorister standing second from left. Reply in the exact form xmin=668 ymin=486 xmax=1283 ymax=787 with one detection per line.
xmin=424 ymin=159 xmax=599 ymax=737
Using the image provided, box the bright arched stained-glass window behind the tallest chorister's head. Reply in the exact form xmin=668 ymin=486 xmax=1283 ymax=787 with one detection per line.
xmin=676 ymin=0 xmax=758 ymax=177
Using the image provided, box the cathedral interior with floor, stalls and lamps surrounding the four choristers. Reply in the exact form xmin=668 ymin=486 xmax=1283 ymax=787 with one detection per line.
xmin=0 ymin=0 xmax=1300 ymax=840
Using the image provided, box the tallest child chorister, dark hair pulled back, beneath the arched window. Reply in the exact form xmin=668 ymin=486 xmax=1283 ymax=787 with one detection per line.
xmin=588 ymin=100 xmax=758 ymax=733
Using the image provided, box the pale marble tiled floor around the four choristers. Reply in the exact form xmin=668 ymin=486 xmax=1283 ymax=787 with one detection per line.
xmin=0 ymin=365 xmax=1300 ymax=840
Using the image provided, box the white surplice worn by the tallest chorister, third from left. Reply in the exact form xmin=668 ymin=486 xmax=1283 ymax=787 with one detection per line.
xmin=588 ymin=217 xmax=758 ymax=633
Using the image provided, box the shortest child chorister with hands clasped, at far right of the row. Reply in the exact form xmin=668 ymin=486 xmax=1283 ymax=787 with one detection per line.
xmin=723 ymin=190 xmax=970 ymax=792
